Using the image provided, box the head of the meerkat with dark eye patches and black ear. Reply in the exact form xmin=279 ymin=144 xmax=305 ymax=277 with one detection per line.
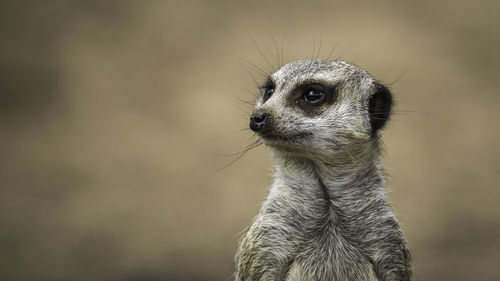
xmin=250 ymin=61 xmax=392 ymax=162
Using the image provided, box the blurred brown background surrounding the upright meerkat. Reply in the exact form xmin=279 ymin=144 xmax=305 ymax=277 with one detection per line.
xmin=0 ymin=0 xmax=500 ymax=281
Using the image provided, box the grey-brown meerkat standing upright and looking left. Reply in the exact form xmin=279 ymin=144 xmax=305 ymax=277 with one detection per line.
xmin=235 ymin=60 xmax=412 ymax=281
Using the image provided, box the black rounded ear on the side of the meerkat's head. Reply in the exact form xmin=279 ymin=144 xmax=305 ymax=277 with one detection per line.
xmin=368 ymin=83 xmax=392 ymax=135
